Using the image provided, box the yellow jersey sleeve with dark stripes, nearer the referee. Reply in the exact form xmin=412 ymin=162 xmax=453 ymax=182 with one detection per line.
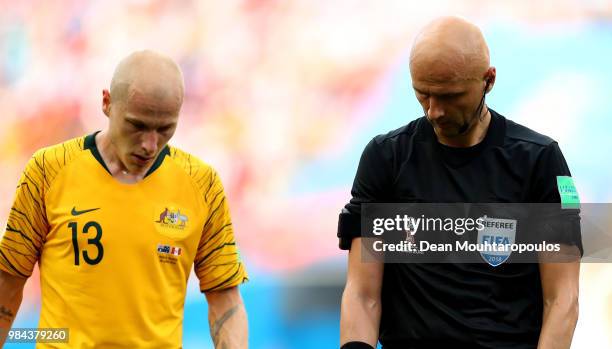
xmin=194 ymin=171 xmax=248 ymax=292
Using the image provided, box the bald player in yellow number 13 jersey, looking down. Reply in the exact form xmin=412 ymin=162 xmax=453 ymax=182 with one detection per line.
xmin=0 ymin=51 xmax=248 ymax=348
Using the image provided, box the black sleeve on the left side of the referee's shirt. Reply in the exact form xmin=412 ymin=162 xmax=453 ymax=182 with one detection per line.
xmin=337 ymin=138 xmax=392 ymax=250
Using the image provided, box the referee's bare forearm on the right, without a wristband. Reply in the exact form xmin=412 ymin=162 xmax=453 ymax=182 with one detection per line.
xmin=538 ymin=299 xmax=578 ymax=349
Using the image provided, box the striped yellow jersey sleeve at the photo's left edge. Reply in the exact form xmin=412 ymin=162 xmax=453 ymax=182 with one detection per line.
xmin=0 ymin=152 xmax=48 ymax=278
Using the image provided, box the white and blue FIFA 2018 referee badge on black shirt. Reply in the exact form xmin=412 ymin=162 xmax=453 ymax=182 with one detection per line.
xmin=477 ymin=216 xmax=516 ymax=267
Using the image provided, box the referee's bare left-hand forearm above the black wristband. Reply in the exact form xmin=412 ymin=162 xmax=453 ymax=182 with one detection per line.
xmin=340 ymin=286 xmax=381 ymax=347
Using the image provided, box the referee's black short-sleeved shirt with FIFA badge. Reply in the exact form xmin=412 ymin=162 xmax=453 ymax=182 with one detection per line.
xmin=338 ymin=109 xmax=584 ymax=349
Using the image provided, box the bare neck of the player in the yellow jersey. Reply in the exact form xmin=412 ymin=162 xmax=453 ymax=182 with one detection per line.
xmin=95 ymin=130 xmax=151 ymax=184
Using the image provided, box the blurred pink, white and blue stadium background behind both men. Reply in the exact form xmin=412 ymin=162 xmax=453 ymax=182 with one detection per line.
xmin=0 ymin=0 xmax=612 ymax=349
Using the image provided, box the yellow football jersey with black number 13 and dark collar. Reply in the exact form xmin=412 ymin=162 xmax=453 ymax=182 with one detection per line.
xmin=0 ymin=134 xmax=247 ymax=348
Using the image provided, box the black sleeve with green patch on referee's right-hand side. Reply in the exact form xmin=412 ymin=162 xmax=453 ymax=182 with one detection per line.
xmin=530 ymin=142 xmax=584 ymax=255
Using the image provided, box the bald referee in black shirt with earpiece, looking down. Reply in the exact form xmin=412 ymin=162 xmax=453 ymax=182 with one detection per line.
xmin=338 ymin=17 xmax=582 ymax=349
